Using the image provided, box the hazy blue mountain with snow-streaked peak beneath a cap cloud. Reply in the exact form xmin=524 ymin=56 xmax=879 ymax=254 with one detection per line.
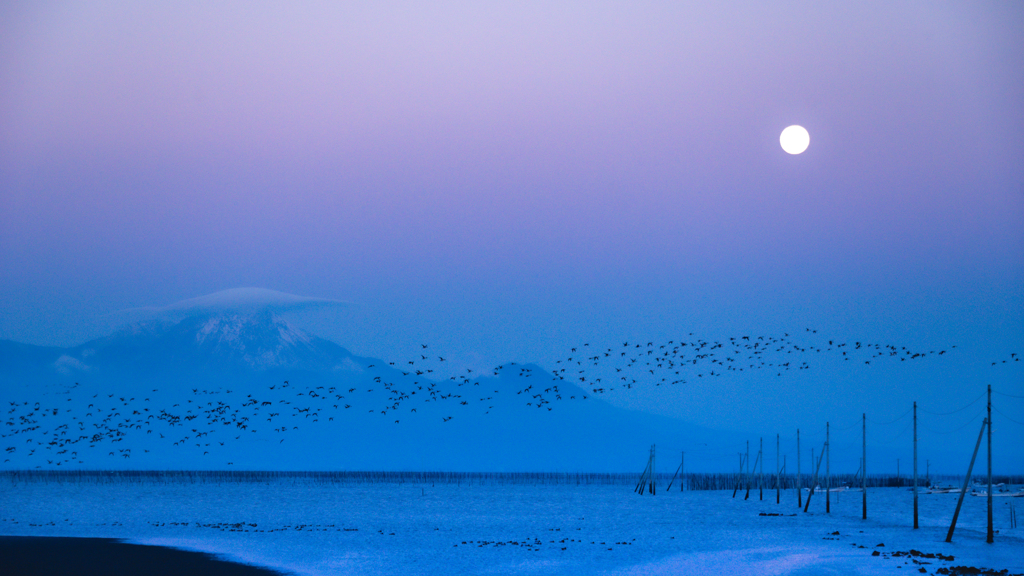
xmin=0 ymin=306 xmax=740 ymax=472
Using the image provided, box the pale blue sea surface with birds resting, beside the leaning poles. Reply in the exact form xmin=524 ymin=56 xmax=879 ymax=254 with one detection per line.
xmin=0 ymin=479 xmax=1024 ymax=576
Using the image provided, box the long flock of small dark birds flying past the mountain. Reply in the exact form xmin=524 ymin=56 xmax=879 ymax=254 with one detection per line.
xmin=0 ymin=329 xmax=1020 ymax=467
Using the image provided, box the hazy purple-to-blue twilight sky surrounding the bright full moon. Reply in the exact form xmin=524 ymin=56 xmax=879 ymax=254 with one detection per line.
xmin=0 ymin=1 xmax=1024 ymax=446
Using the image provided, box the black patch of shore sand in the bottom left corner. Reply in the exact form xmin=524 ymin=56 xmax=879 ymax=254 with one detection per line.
xmin=0 ymin=536 xmax=280 ymax=576
